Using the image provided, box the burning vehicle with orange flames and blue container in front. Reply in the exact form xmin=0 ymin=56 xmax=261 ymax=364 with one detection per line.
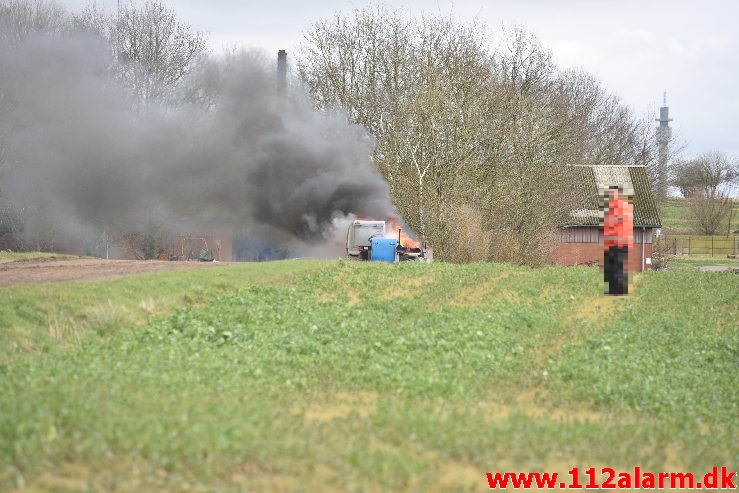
xmin=346 ymin=219 xmax=433 ymax=263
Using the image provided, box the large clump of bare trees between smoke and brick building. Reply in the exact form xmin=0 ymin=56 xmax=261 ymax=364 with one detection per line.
xmin=299 ymin=7 xmax=660 ymax=265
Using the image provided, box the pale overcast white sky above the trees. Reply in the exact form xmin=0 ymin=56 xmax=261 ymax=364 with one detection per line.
xmin=60 ymin=0 xmax=739 ymax=156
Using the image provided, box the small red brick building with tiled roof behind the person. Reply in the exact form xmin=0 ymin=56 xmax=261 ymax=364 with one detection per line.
xmin=554 ymin=165 xmax=662 ymax=272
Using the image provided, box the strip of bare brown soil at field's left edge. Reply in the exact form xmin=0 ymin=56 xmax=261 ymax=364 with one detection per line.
xmin=0 ymin=257 xmax=228 ymax=286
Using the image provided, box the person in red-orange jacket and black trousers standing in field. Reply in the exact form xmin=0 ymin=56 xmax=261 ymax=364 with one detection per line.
xmin=603 ymin=186 xmax=634 ymax=295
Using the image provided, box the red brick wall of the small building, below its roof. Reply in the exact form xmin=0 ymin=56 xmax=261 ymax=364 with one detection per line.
xmin=554 ymin=227 xmax=652 ymax=272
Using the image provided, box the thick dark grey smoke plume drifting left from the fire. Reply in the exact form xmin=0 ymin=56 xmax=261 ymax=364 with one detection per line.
xmin=0 ymin=30 xmax=392 ymax=254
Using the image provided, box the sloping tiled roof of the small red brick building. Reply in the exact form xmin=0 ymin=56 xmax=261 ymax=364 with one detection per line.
xmin=564 ymin=165 xmax=662 ymax=228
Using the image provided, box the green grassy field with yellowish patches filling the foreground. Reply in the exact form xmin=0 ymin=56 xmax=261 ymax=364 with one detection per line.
xmin=0 ymin=261 xmax=739 ymax=492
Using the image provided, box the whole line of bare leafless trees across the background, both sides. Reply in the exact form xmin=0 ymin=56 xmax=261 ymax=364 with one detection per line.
xmin=0 ymin=0 xmax=737 ymax=265
